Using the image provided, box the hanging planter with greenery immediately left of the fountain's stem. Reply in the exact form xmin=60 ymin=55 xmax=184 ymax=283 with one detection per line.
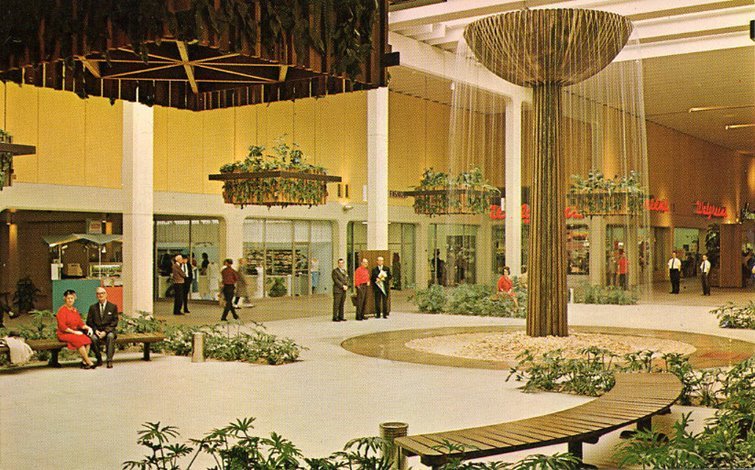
xmin=404 ymin=168 xmax=501 ymax=217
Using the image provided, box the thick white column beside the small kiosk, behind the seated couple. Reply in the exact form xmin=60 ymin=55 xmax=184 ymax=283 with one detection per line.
xmin=121 ymin=102 xmax=155 ymax=315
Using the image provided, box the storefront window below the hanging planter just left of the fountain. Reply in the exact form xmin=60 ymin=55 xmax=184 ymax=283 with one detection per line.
xmin=427 ymin=224 xmax=478 ymax=286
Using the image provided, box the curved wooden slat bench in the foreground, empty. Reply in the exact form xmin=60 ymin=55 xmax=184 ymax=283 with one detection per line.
xmin=395 ymin=373 xmax=682 ymax=468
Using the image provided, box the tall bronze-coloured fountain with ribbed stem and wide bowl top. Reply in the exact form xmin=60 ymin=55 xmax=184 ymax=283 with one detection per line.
xmin=464 ymin=9 xmax=632 ymax=336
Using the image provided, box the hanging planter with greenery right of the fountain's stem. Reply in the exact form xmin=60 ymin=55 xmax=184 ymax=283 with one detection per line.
xmin=569 ymin=169 xmax=648 ymax=217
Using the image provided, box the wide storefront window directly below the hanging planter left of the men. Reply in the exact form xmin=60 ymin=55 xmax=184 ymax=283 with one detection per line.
xmin=244 ymin=219 xmax=333 ymax=298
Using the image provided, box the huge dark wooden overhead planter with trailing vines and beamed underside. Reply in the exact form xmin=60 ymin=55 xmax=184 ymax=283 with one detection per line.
xmin=0 ymin=0 xmax=388 ymax=111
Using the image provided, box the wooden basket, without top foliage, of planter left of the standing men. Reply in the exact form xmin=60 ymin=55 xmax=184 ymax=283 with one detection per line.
xmin=210 ymin=170 xmax=341 ymax=208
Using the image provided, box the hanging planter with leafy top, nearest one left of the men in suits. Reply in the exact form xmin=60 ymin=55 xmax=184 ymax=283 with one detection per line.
xmin=210 ymin=136 xmax=341 ymax=208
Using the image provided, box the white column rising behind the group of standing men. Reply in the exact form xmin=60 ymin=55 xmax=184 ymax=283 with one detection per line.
xmin=367 ymin=87 xmax=388 ymax=250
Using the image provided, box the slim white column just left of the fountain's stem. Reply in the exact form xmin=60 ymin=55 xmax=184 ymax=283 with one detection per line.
xmin=505 ymin=98 xmax=522 ymax=276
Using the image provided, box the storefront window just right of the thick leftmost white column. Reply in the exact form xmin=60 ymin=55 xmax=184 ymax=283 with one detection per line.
xmin=154 ymin=219 xmax=221 ymax=300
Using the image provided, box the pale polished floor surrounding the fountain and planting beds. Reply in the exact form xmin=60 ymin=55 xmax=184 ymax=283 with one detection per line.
xmin=0 ymin=283 xmax=755 ymax=470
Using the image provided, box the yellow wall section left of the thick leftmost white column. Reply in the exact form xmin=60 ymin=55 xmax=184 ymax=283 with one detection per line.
xmin=0 ymin=84 xmax=123 ymax=188
